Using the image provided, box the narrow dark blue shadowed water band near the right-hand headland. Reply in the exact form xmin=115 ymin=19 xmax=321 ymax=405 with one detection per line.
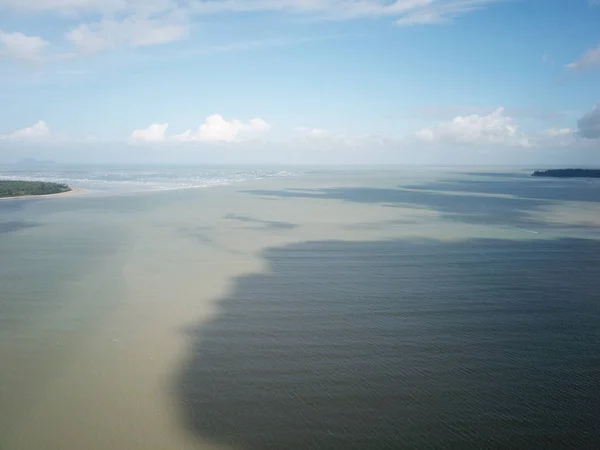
xmin=248 ymin=173 xmax=600 ymax=228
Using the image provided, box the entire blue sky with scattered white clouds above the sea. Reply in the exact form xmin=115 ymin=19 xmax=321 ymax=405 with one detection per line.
xmin=0 ymin=0 xmax=600 ymax=166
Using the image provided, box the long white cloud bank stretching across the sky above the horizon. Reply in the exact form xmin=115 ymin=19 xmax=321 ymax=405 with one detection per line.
xmin=0 ymin=105 xmax=600 ymax=164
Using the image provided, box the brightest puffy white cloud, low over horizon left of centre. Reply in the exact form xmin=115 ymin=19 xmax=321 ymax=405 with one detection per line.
xmin=173 ymin=114 xmax=271 ymax=142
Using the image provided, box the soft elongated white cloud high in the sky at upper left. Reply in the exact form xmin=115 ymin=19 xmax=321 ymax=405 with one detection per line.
xmin=66 ymin=18 xmax=189 ymax=53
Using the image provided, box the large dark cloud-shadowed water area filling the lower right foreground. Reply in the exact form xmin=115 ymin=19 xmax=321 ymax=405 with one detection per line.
xmin=178 ymin=240 xmax=600 ymax=449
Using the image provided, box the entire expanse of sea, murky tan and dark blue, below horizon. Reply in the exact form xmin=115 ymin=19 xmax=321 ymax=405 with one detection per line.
xmin=0 ymin=167 xmax=600 ymax=450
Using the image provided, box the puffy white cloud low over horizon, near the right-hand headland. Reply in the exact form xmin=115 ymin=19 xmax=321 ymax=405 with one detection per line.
xmin=417 ymin=108 xmax=531 ymax=147
